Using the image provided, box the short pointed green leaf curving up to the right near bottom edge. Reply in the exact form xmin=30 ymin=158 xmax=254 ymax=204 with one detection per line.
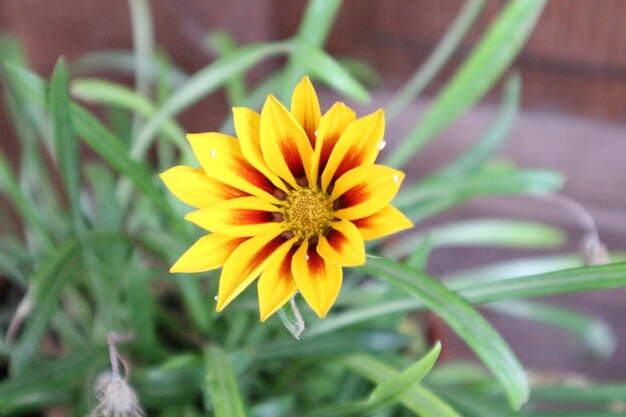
xmin=368 ymin=342 xmax=441 ymax=406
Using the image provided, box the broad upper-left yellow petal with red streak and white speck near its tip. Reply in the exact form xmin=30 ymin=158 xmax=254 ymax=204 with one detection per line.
xmin=187 ymin=132 xmax=278 ymax=202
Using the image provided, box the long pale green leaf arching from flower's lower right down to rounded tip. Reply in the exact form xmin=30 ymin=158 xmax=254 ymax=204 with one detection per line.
xmin=363 ymin=259 xmax=528 ymax=409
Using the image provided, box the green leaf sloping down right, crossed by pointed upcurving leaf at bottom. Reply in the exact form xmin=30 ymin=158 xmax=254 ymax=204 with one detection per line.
xmin=346 ymin=355 xmax=461 ymax=417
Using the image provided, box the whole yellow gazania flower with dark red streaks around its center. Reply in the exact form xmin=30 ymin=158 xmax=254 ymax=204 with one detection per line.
xmin=161 ymin=77 xmax=412 ymax=320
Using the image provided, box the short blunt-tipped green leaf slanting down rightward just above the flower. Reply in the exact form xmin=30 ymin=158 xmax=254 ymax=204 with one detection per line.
xmin=294 ymin=42 xmax=369 ymax=102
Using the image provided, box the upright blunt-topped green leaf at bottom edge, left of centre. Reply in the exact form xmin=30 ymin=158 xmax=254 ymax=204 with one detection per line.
xmin=204 ymin=346 xmax=246 ymax=417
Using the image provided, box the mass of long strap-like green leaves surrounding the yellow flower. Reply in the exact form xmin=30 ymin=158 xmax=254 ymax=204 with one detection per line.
xmin=0 ymin=0 xmax=626 ymax=417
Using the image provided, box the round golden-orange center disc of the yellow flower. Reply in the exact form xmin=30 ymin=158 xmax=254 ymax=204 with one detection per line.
xmin=283 ymin=188 xmax=334 ymax=239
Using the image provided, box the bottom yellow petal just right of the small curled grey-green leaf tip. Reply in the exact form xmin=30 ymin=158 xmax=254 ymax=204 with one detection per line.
xmin=291 ymin=240 xmax=343 ymax=318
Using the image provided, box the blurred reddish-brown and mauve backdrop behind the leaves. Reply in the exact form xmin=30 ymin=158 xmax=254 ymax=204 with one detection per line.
xmin=0 ymin=0 xmax=626 ymax=378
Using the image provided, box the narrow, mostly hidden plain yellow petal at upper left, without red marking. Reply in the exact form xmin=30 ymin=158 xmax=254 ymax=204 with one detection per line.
xmin=233 ymin=107 xmax=287 ymax=191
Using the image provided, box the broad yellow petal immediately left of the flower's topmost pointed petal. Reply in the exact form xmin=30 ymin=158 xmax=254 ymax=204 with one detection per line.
xmin=261 ymin=95 xmax=313 ymax=188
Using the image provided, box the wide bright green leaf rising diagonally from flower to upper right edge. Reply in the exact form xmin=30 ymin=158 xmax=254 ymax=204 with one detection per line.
xmin=385 ymin=0 xmax=546 ymax=167
